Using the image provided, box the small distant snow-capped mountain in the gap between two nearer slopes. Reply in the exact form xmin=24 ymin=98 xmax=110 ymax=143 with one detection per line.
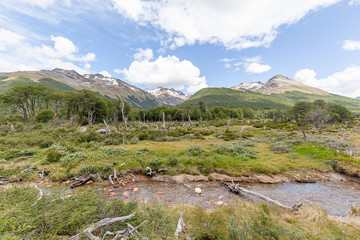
xmin=145 ymin=87 xmax=189 ymax=106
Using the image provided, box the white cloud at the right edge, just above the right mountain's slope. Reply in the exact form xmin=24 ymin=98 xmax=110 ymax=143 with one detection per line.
xmin=294 ymin=66 xmax=360 ymax=97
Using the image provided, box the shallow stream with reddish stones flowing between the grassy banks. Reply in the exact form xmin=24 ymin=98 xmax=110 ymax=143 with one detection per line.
xmin=106 ymin=176 xmax=360 ymax=215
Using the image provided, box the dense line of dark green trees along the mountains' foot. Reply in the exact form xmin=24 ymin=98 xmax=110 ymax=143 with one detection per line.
xmin=0 ymin=84 xmax=352 ymax=126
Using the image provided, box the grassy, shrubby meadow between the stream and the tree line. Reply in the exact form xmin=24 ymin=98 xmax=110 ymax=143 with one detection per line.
xmin=0 ymin=123 xmax=360 ymax=180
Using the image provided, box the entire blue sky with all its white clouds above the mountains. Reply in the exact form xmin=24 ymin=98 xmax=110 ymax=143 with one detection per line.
xmin=0 ymin=0 xmax=360 ymax=97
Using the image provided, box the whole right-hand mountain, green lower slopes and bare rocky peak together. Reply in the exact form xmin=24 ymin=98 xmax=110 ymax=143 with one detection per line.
xmin=178 ymin=75 xmax=360 ymax=114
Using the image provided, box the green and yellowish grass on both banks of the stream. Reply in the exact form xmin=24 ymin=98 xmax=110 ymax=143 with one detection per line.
xmin=0 ymin=121 xmax=360 ymax=239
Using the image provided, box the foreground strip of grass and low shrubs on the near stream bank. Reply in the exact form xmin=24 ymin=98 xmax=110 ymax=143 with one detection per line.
xmin=0 ymin=187 xmax=360 ymax=239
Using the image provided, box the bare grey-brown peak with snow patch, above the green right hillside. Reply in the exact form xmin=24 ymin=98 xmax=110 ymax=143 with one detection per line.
xmin=232 ymin=74 xmax=329 ymax=95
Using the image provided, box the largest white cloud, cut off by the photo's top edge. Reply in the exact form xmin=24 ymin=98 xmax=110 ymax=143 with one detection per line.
xmin=112 ymin=0 xmax=341 ymax=49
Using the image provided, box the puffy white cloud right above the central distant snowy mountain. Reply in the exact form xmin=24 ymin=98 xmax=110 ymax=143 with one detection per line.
xmin=119 ymin=56 xmax=208 ymax=94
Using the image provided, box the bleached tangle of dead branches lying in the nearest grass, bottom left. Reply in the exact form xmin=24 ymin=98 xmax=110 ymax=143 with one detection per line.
xmin=69 ymin=213 xmax=146 ymax=240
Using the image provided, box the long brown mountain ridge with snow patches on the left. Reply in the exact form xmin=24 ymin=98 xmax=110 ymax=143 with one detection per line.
xmin=0 ymin=68 xmax=163 ymax=109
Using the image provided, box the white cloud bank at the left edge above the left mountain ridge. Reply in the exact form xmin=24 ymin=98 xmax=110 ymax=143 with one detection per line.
xmin=0 ymin=29 xmax=96 ymax=73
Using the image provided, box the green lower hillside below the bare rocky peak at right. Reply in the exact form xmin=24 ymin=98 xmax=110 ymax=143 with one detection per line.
xmin=178 ymin=88 xmax=360 ymax=114
